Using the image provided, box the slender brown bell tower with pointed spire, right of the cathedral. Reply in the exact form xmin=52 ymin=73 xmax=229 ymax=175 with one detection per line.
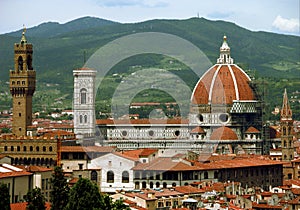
xmin=280 ymin=89 xmax=294 ymax=161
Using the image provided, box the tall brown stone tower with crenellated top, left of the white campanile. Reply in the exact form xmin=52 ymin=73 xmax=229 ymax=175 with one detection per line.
xmin=9 ymin=28 xmax=36 ymax=136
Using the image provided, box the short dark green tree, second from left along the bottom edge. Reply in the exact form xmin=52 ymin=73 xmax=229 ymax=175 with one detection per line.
xmin=25 ymin=187 xmax=46 ymax=210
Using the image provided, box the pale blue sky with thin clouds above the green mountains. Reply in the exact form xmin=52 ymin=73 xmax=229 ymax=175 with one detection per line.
xmin=0 ymin=0 xmax=300 ymax=36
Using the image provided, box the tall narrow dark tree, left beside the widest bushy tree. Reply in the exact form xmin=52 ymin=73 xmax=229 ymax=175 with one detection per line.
xmin=50 ymin=166 xmax=69 ymax=210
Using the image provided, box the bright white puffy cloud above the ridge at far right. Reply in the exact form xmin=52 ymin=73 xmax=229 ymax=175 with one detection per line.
xmin=272 ymin=15 xmax=300 ymax=33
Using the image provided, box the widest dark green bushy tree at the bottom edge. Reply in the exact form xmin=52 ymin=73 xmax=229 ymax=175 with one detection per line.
xmin=66 ymin=178 xmax=103 ymax=210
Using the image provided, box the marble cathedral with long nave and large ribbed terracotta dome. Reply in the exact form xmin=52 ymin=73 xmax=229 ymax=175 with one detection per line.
xmin=89 ymin=37 xmax=264 ymax=154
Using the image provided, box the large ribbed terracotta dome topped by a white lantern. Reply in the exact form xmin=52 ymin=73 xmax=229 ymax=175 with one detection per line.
xmin=191 ymin=37 xmax=256 ymax=104
